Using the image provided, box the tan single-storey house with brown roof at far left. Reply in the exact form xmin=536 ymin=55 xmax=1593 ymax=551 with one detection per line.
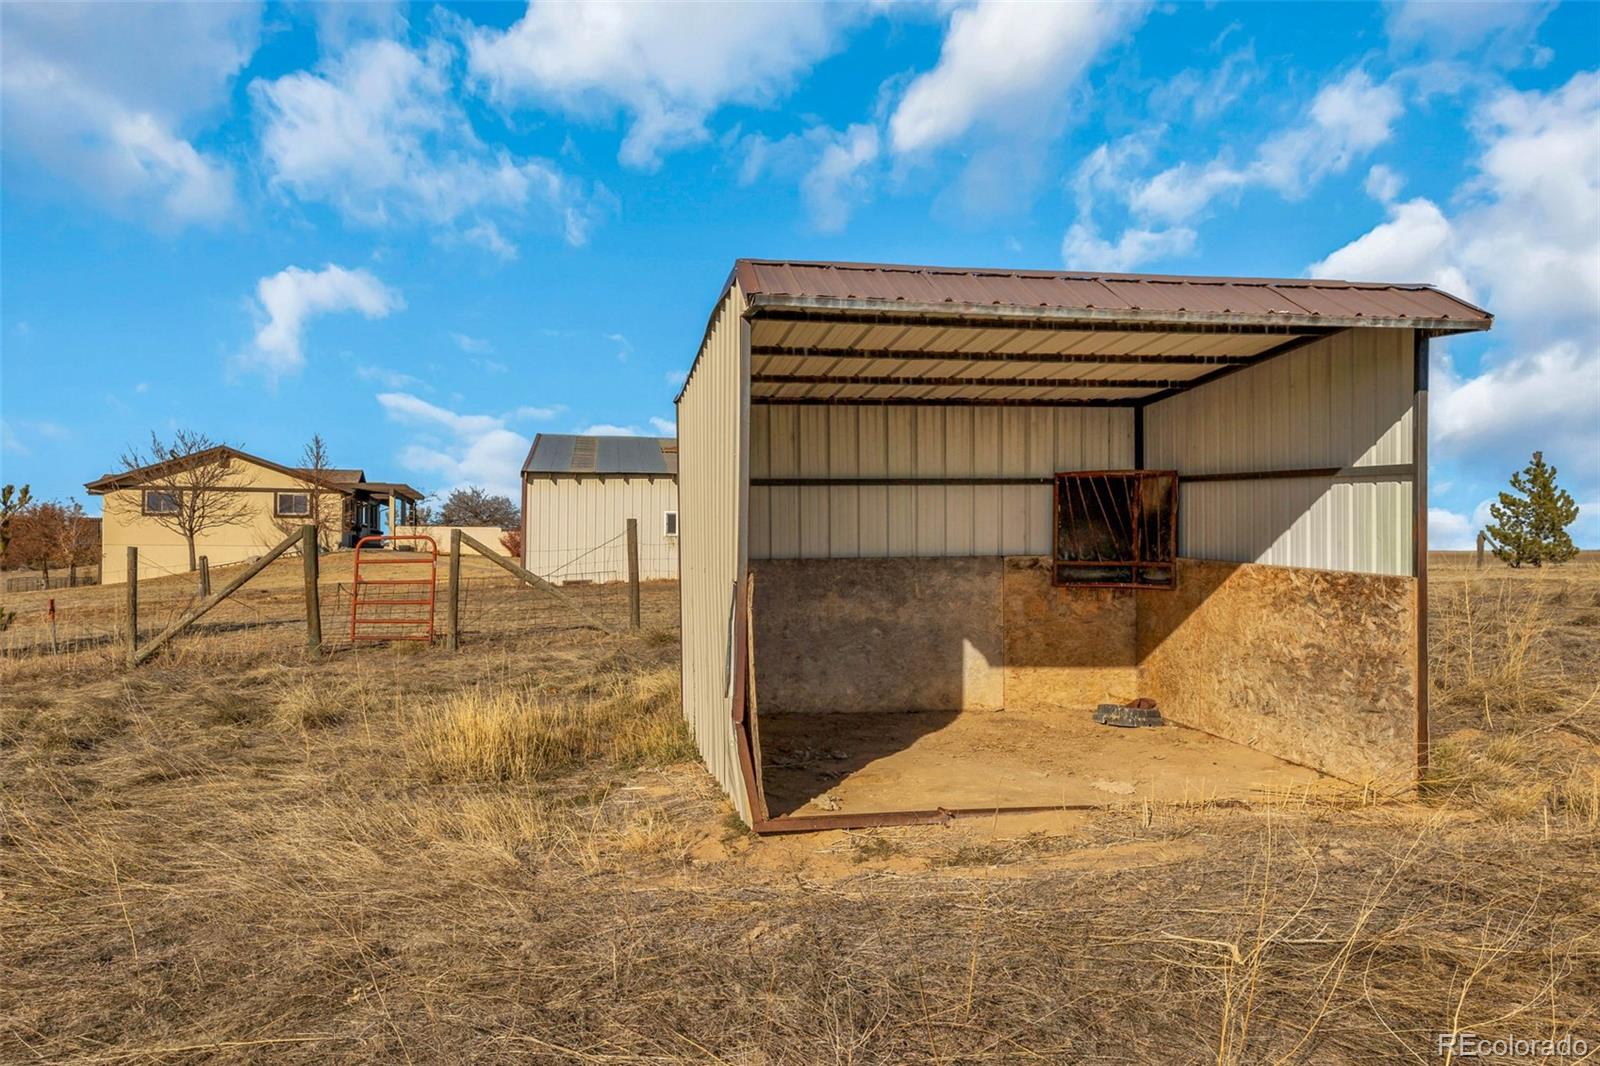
xmin=83 ymin=445 xmax=422 ymax=584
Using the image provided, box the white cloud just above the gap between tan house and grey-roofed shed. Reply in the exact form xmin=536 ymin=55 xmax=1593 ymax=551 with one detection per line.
xmin=378 ymin=392 xmax=530 ymax=499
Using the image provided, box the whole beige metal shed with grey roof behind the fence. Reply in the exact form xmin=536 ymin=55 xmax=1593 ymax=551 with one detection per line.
xmin=522 ymin=434 xmax=678 ymax=583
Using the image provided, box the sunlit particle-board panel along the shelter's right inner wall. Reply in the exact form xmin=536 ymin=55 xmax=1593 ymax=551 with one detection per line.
xmin=1138 ymin=560 xmax=1416 ymax=783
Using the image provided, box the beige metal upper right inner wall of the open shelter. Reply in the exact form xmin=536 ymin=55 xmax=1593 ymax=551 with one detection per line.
xmin=1144 ymin=330 xmax=1413 ymax=575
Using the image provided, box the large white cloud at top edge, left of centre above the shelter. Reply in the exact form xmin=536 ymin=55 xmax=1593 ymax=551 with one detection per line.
xmin=467 ymin=0 xmax=850 ymax=166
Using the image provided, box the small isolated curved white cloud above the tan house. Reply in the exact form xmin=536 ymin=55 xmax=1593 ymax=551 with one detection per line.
xmin=240 ymin=264 xmax=405 ymax=378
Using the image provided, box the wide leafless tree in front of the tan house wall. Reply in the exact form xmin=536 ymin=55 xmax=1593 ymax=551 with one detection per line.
xmin=122 ymin=429 xmax=251 ymax=571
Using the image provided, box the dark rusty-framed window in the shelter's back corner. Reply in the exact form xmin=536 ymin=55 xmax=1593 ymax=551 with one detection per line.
xmin=1054 ymin=471 xmax=1178 ymax=589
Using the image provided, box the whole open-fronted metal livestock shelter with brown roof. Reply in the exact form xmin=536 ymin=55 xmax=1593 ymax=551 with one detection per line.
xmin=677 ymin=259 xmax=1493 ymax=831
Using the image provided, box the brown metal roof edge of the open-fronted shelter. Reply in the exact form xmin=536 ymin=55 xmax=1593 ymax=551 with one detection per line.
xmin=734 ymin=259 xmax=1493 ymax=333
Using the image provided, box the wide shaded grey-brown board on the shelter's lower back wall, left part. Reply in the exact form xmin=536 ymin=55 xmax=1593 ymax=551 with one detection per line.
xmin=750 ymin=559 xmax=1005 ymax=714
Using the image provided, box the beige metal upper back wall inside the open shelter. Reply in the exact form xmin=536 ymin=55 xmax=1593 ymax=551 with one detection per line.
xmin=750 ymin=403 xmax=1133 ymax=559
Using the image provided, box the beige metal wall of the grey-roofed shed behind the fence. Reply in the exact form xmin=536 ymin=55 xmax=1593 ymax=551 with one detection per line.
xmin=522 ymin=474 xmax=678 ymax=581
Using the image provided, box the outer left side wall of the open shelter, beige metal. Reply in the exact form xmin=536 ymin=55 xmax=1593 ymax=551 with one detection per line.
xmin=678 ymin=285 xmax=750 ymax=823
